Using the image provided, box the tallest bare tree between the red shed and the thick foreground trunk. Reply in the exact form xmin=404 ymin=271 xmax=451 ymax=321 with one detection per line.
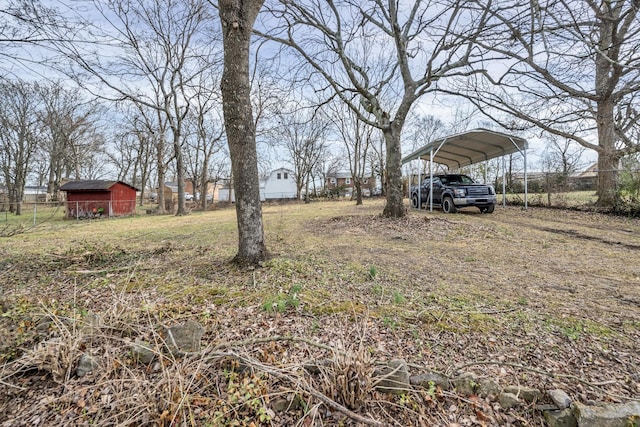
xmin=47 ymin=0 xmax=215 ymax=215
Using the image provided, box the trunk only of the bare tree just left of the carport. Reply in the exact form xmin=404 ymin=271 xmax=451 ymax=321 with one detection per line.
xmin=383 ymin=126 xmax=407 ymax=218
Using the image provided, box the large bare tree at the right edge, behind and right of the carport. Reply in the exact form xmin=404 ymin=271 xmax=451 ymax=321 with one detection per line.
xmin=456 ymin=0 xmax=640 ymax=207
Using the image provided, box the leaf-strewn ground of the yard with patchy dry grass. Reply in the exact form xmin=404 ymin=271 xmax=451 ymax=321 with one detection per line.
xmin=0 ymin=202 xmax=640 ymax=426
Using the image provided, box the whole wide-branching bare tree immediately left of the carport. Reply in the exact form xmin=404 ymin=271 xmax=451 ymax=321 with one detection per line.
xmin=261 ymin=0 xmax=484 ymax=218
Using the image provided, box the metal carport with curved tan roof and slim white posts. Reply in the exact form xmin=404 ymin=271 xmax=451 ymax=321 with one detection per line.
xmin=402 ymin=128 xmax=528 ymax=210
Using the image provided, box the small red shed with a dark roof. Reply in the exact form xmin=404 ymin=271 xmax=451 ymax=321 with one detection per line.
xmin=60 ymin=180 xmax=138 ymax=218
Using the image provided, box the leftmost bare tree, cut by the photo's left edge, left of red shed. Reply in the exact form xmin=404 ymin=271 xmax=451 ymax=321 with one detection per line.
xmin=0 ymin=81 xmax=40 ymax=215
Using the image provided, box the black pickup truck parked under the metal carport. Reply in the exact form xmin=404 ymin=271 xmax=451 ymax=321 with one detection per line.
xmin=411 ymin=174 xmax=497 ymax=213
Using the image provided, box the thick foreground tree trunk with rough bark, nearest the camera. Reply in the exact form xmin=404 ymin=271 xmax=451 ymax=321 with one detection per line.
xmin=219 ymin=0 xmax=267 ymax=264
